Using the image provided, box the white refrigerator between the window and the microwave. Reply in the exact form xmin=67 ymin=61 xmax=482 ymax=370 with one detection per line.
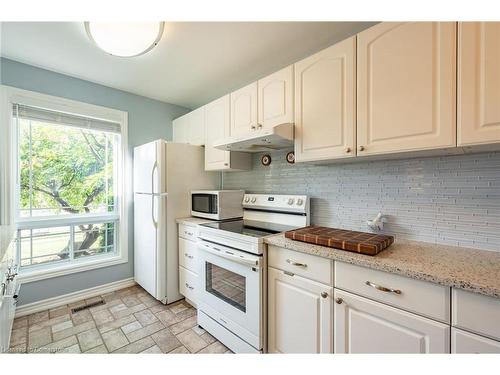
xmin=134 ymin=140 xmax=220 ymax=304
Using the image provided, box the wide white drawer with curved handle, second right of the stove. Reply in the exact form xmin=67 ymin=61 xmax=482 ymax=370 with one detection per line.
xmin=335 ymin=262 xmax=450 ymax=323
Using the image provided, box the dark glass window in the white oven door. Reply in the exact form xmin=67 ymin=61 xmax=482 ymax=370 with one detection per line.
xmin=205 ymin=262 xmax=247 ymax=312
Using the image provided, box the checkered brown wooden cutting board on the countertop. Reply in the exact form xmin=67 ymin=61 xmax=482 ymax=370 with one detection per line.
xmin=285 ymin=225 xmax=394 ymax=255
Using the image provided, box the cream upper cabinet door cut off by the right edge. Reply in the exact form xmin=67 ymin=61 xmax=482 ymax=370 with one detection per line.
xmin=458 ymin=22 xmax=500 ymax=146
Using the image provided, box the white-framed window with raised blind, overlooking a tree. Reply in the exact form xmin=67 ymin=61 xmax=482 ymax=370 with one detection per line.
xmin=7 ymin=97 xmax=126 ymax=278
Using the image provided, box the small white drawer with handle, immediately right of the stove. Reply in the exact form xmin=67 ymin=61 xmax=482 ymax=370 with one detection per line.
xmin=267 ymin=246 xmax=333 ymax=285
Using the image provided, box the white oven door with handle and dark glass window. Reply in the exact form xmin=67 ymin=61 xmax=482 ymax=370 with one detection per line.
xmin=198 ymin=241 xmax=264 ymax=349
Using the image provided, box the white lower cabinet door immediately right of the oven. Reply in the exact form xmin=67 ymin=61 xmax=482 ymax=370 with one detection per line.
xmin=268 ymin=267 xmax=333 ymax=353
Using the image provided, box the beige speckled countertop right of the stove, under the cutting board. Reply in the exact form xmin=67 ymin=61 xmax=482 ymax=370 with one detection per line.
xmin=265 ymin=234 xmax=500 ymax=298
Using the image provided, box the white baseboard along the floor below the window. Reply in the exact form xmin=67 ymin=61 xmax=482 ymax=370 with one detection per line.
xmin=16 ymin=277 xmax=135 ymax=318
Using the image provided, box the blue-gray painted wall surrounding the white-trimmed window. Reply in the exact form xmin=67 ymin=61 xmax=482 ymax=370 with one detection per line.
xmin=0 ymin=58 xmax=189 ymax=305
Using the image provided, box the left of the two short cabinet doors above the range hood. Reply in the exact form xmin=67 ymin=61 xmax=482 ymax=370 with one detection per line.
xmin=230 ymin=82 xmax=257 ymax=137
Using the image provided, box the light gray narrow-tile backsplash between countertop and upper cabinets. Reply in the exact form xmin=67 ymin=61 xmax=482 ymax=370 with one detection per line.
xmin=224 ymin=152 xmax=500 ymax=251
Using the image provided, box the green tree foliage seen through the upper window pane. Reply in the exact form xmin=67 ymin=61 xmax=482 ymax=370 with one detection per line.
xmin=19 ymin=120 xmax=113 ymax=214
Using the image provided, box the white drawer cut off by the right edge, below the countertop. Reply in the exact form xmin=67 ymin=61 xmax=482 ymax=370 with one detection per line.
xmin=452 ymin=289 xmax=500 ymax=340
